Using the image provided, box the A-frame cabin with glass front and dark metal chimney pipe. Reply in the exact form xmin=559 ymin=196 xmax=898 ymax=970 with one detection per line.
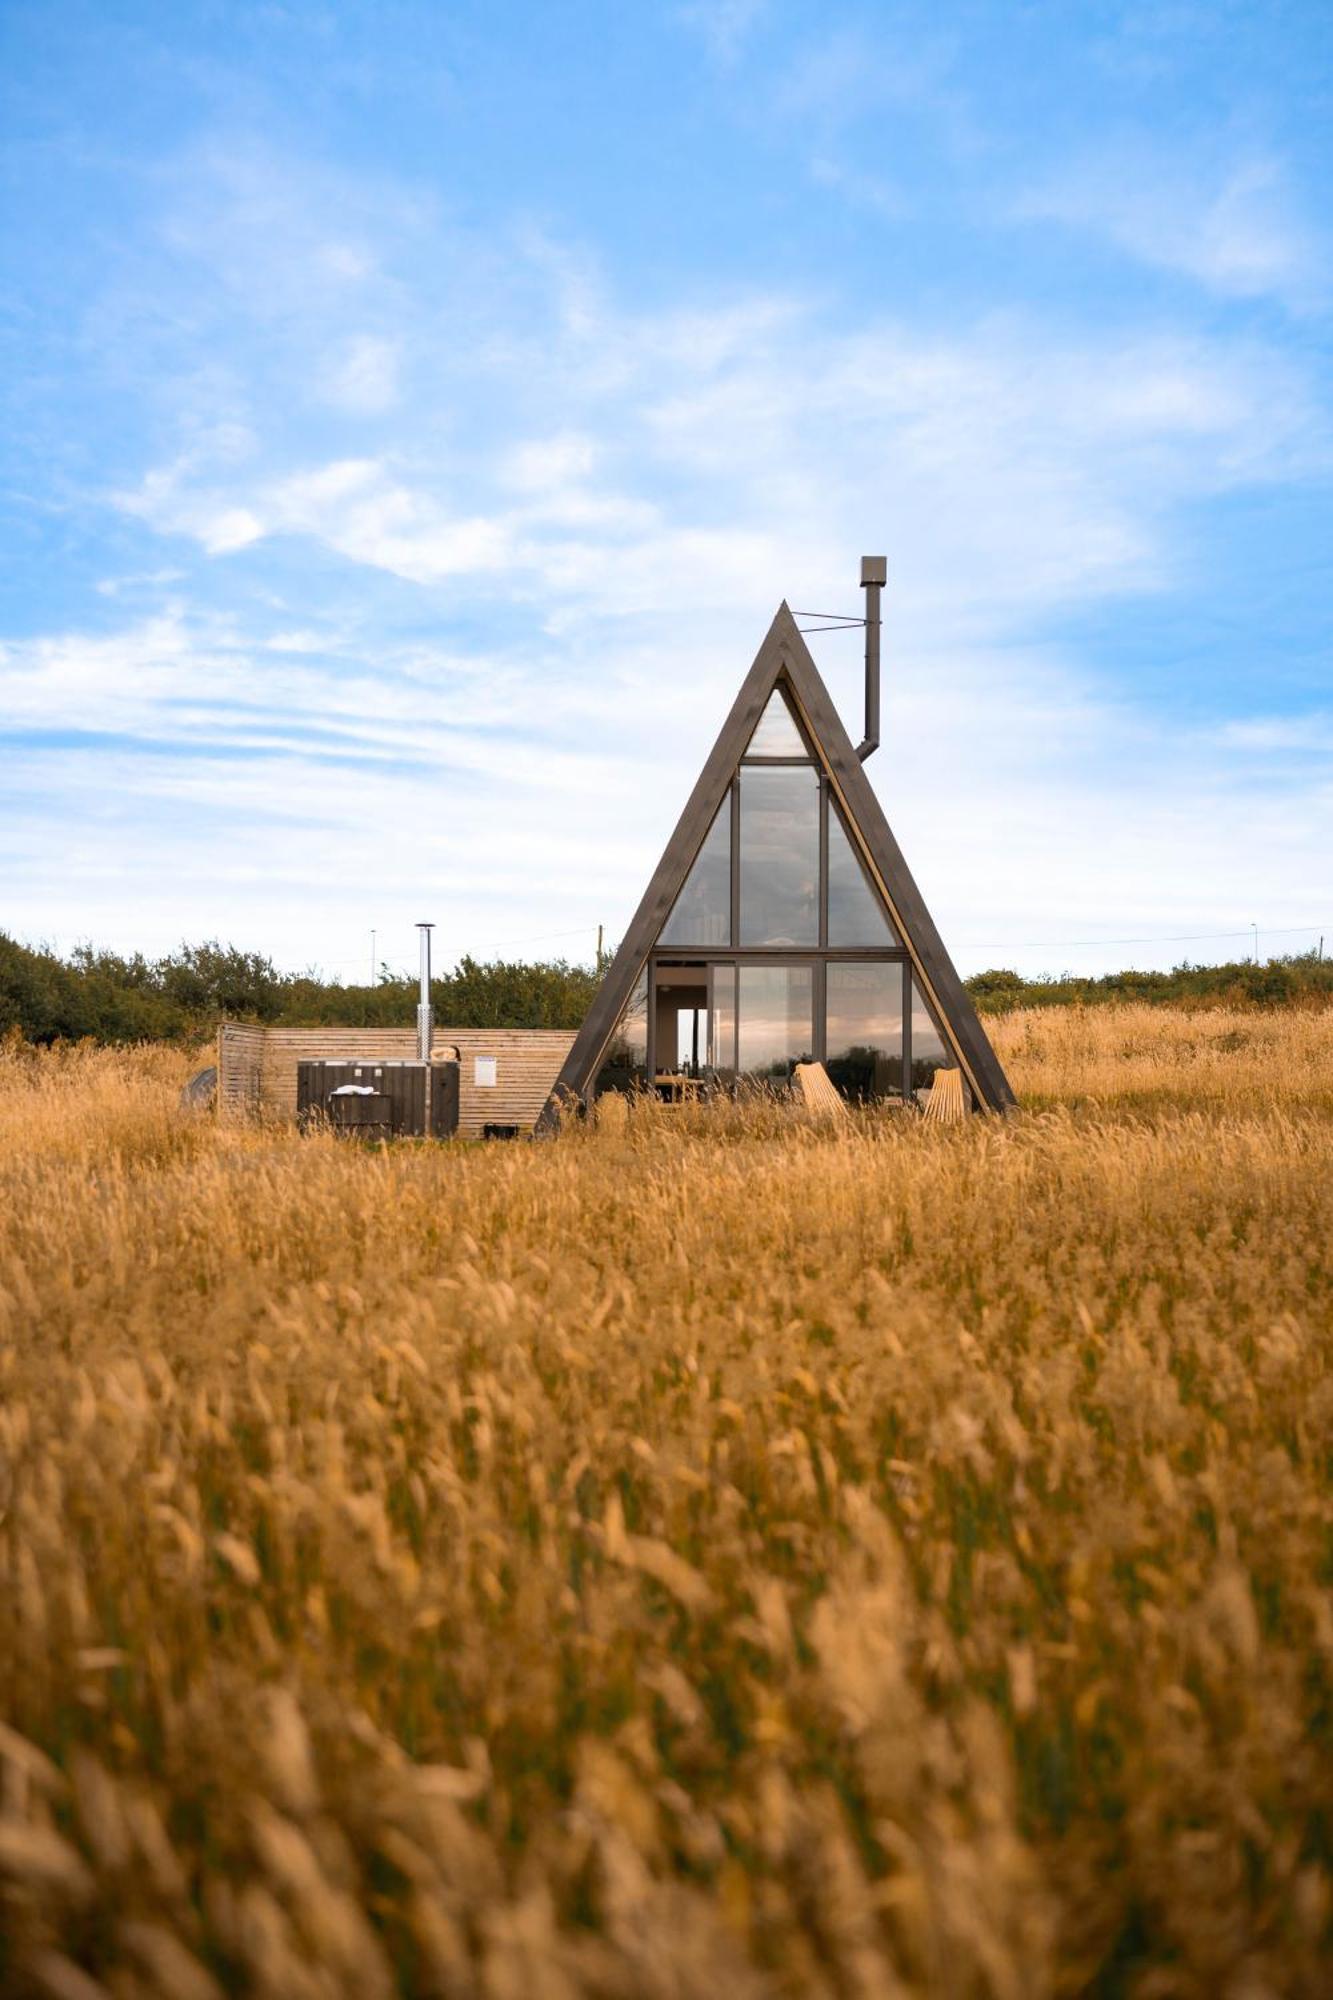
xmin=542 ymin=588 xmax=1015 ymax=1126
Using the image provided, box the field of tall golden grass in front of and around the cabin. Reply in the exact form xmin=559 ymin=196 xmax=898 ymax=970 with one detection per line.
xmin=0 ymin=1008 xmax=1333 ymax=2000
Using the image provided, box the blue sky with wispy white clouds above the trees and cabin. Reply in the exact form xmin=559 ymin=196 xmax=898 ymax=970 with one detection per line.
xmin=0 ymin=0 xmax=1333 ymax=976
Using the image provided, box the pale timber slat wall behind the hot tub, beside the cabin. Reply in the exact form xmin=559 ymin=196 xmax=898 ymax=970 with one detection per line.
xmin=218 ymin=1022 xmax=574 ymax=1138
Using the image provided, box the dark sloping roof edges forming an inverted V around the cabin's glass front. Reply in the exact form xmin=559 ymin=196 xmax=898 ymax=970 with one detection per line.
xmin=542 ymin=600 xmax=1015 ymax=1124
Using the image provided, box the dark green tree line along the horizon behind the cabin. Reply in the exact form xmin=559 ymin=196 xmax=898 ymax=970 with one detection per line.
xmin=0 ymin=932 xmax=1333 ymax=1042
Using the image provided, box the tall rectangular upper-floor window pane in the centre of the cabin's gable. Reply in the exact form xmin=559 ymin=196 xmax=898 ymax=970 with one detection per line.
xmin=737 ymin=766 xmax=819 ymax=944
